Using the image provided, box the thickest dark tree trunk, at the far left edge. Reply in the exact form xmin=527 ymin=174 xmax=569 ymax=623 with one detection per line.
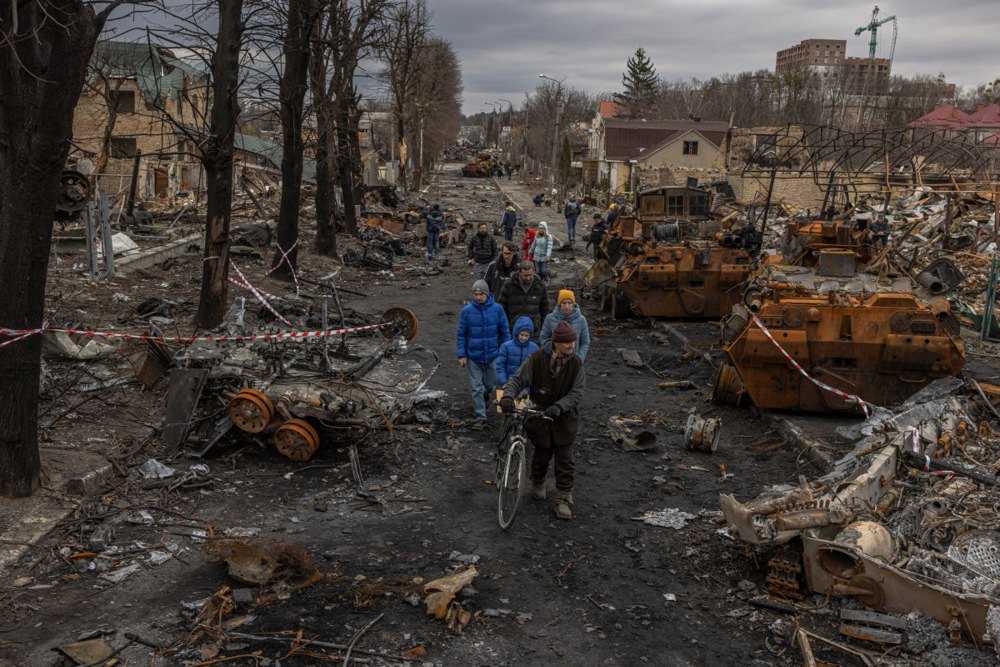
xmin=0 ymin=0 xmax=103 ymax=496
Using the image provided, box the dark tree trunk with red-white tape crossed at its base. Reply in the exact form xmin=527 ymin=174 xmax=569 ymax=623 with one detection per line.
xmin=271 ymin=0 xmax=316 ymax=280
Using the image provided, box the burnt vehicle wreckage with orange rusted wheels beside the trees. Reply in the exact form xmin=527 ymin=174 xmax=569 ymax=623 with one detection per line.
xmin=146 ymin=308 xmax=441 ymax=472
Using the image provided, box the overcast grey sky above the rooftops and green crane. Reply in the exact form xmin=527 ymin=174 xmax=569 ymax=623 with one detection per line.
xmin=428 ymin=0 xmax=1000 ymax=114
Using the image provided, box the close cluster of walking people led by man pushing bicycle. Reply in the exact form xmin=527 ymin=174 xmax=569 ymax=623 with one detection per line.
xmin=455 ymin=198 xmax=590 ymax=519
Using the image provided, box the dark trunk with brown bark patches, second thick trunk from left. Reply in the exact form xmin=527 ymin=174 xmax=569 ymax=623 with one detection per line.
xmin=195 ymin=0 xmax=243 ymax=329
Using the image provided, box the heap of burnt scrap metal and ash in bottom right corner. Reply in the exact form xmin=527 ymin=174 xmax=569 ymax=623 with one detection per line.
xmin=720 ymin=378 xmax=1000 ymax=665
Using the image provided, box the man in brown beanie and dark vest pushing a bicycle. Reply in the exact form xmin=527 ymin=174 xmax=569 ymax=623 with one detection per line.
xmin=500 ymin=322 xmax=585 ymax=519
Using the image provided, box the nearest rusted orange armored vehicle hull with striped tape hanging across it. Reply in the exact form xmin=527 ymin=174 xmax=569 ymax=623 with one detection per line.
xmin=714 ymin=249 xmax=965 ymax=412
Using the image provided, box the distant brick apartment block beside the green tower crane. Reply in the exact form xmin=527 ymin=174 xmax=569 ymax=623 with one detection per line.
xmin=774 ymin=39 xmax=892 ymax=95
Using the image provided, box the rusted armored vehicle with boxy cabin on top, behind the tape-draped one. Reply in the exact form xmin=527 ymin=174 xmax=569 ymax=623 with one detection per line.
xmin=588 ymin=187 xmax=754 ymax=319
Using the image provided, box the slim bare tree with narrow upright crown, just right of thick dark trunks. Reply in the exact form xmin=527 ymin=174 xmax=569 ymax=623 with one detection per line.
xmin=379 ymin=0 xmax=430 ymax=189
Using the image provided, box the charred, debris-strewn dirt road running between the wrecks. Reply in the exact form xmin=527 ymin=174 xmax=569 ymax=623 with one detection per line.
xmin=0 ymin=167 xmax=808 ymax=665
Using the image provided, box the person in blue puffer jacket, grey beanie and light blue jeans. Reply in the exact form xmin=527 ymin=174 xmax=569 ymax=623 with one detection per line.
xmin=455 ymin=279 xmax=510 ymax=428
